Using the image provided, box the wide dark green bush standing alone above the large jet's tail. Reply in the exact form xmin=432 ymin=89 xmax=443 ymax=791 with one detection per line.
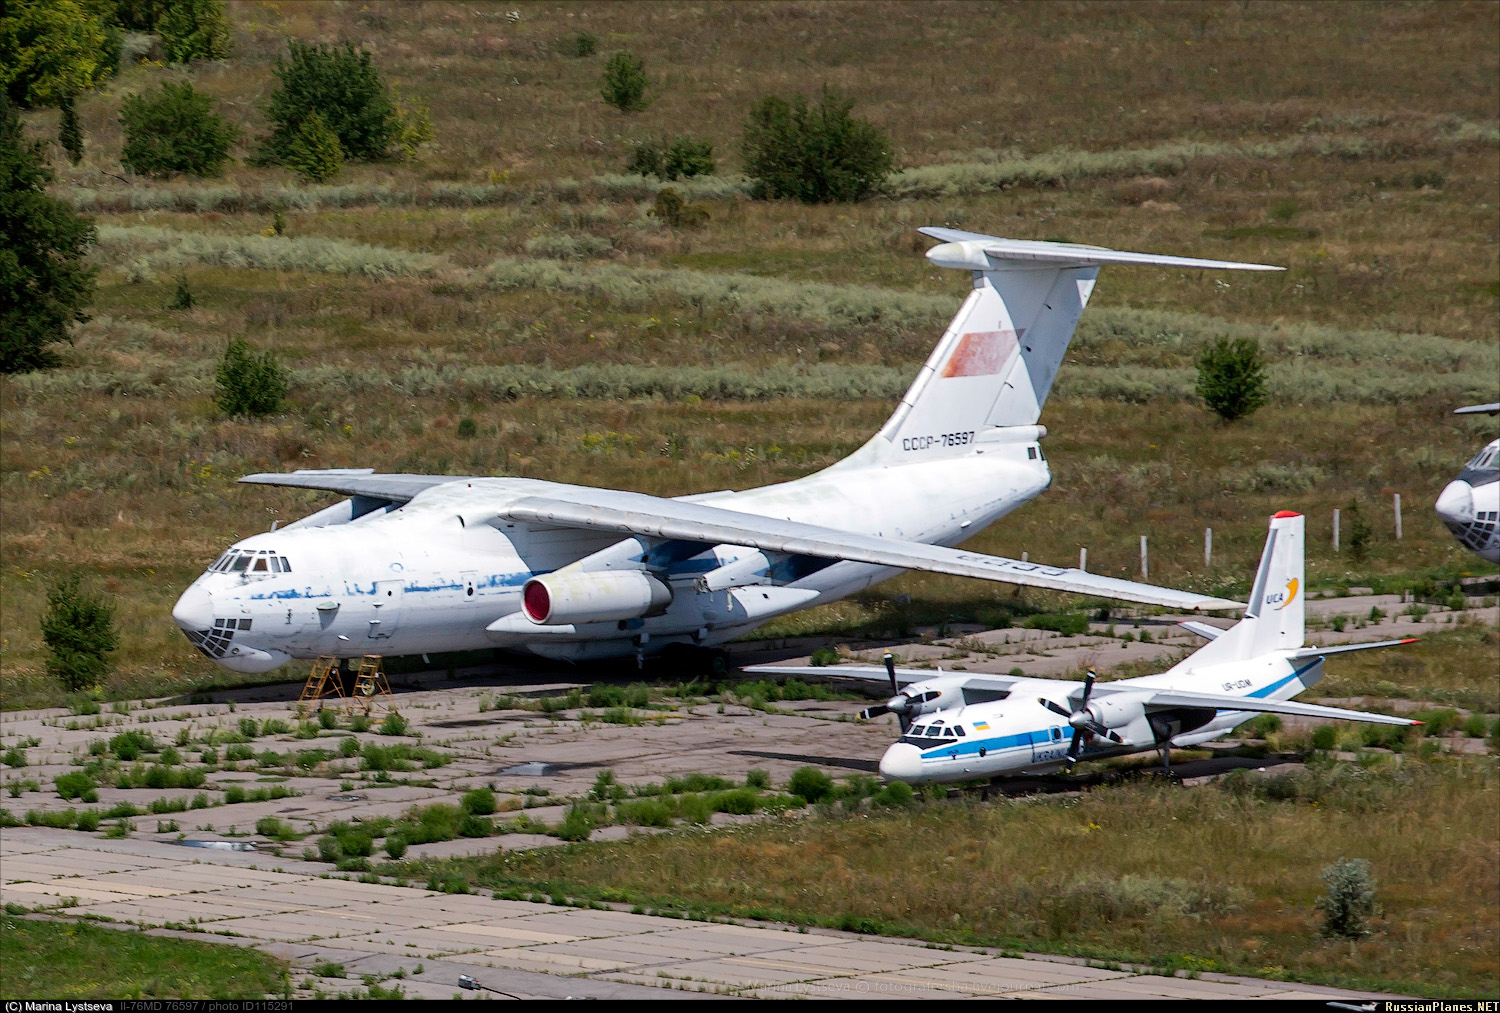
xmin=741 ymin=89 xmax=894 ymax=204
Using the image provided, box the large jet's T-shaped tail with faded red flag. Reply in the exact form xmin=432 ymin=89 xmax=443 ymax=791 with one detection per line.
xmin=851 ymin=228 xmax=1283 ymax=465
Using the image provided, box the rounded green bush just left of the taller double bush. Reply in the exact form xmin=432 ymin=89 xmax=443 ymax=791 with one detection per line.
xmin=120 ymin=81 xmax=240 ymax=176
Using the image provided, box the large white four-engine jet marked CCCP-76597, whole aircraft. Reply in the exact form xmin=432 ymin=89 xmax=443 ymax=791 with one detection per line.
xmin=173 ymin=228 xmax=1281 ymax=672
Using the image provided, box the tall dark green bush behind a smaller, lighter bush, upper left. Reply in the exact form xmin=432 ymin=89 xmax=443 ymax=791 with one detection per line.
xmin=257 ymin=39 xmax=401 ymax=165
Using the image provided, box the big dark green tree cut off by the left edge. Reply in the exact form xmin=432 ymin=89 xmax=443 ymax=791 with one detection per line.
xmin=0 ymin=95 xmax=95 ymax=374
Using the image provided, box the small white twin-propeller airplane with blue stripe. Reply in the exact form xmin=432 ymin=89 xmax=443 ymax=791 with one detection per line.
xmin=746 ymin=510 xmax=1422 ymax=783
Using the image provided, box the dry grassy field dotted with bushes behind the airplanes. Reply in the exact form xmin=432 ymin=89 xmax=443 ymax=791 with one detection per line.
xmin=0 ymin=0 xmax=1500 ymax=705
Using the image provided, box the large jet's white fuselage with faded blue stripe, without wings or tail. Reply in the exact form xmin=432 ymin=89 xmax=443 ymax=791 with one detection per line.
xmin=173 ymin=443 xmax=1052 ymax=672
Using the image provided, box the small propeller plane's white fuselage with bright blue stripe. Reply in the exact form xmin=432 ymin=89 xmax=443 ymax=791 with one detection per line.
xmin=881 ymin=654 xmax=1323 ymax=783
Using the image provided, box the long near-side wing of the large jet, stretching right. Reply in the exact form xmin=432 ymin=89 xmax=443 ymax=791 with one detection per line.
xmin=494 ymin=486 xmax=1245 ymax=609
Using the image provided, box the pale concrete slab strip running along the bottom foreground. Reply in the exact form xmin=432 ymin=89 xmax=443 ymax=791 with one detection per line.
xmin=0 ymin=827 xmax=1400 ymax=1001
